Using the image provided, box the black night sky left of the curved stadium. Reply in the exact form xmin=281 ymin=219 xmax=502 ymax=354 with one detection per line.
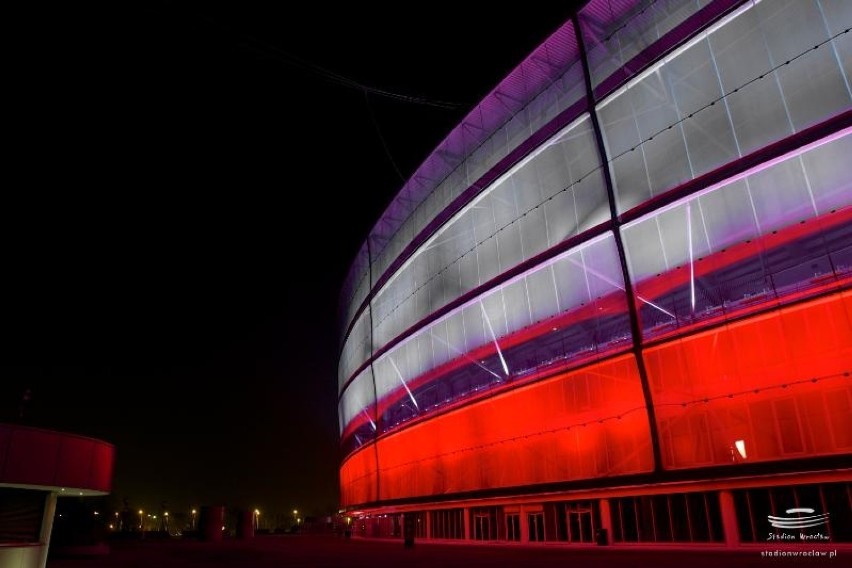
xmin=0 ymin=1 xmax=570 ymax=512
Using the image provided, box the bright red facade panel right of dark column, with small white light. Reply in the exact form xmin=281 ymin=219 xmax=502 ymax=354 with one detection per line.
xmin=644 ymin=292 xmax=852 ymax=468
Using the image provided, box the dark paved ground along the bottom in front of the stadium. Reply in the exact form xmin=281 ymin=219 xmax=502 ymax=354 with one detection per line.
xmin=47 ymin=536 xmax=852 ymax=568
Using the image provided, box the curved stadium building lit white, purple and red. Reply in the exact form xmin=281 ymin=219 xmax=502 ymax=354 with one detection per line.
xmin=339 ymin=0 xmax=852 ymax=546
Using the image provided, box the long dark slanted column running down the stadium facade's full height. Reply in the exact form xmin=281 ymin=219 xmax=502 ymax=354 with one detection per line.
xmin=571 ymin=12 xmax=663 ymax=472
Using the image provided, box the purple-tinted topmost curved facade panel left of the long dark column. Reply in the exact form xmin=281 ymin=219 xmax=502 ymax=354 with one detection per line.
xmin=371 ymin=22 xmax=585 ymax=290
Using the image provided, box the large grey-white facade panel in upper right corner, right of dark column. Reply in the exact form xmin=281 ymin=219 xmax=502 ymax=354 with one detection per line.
xmin=598 ymin=0 xmax=852 ymax=212
